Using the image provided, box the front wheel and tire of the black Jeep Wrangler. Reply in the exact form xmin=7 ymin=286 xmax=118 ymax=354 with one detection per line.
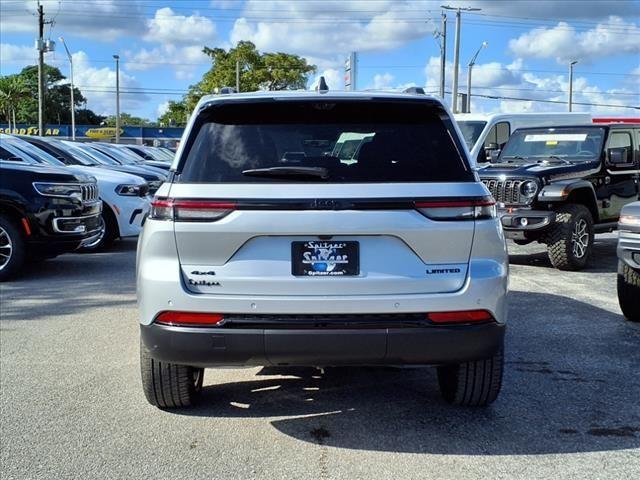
xmin=545 ymin=204 xmax=594 ymax=271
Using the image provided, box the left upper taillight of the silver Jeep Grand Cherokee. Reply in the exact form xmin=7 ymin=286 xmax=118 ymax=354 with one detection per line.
xmin=149 ymin=197 xmax=236 ymax=222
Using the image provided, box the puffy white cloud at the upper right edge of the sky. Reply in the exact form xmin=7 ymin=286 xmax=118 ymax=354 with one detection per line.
xmin=509 ymin=16 xmax=640 ymax=63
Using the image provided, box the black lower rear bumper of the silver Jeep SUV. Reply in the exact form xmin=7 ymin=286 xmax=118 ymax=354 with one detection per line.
xmin=140 ymin=322 xmax=505 ymax=367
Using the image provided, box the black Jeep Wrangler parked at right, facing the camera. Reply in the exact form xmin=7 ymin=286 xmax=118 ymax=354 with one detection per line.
xmin=478 ymin=124 xmax=640 ymax=270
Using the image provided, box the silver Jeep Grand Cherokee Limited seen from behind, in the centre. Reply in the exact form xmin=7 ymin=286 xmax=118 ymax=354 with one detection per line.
xmin=137 ymin=91 xmax=508 ymax=408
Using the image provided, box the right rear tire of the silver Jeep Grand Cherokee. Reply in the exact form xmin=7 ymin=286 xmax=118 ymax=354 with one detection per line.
xmin=438 ymin=350 xmax=504 ymax=407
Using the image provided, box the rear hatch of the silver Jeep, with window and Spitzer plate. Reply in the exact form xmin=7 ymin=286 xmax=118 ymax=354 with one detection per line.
xmin=161 ymin=97 xmax=493 ymax=296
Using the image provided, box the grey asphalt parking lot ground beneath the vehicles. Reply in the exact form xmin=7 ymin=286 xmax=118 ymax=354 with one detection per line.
xmin=0 ymin=234 xmax=640 ymax=480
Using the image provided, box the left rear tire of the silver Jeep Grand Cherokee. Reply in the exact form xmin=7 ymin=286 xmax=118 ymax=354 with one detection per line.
xmin=140 ymin=340 xmax=204 ymax=408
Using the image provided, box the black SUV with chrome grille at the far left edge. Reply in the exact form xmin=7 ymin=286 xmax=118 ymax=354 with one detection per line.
xmin=0 ymin=162 xmax=102 ymax=281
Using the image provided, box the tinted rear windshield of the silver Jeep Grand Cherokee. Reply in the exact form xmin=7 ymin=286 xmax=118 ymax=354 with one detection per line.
xmin=176 ymin=101 xmax=474 ymax=183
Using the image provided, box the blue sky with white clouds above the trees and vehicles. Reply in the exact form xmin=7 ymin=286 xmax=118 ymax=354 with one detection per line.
xmin=0 ymin=0 xmax=640 ymax=119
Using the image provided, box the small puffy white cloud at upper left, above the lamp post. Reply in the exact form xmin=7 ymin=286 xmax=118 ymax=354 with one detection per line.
xmin=144 ymin=7 xmax=216 ymax=46
